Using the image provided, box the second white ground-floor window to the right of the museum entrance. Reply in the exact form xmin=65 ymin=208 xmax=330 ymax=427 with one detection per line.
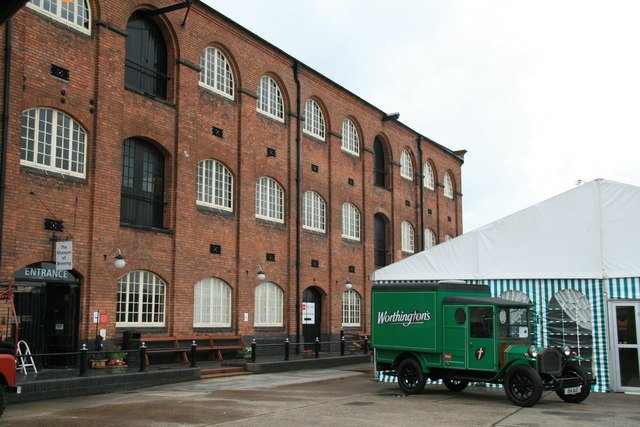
xmin=193 ymin=277 xmax=231 ymax=328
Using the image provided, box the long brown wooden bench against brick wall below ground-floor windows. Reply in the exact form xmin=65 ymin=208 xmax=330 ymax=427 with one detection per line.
xmin=140 ymin=335 xmax=247 ymax=366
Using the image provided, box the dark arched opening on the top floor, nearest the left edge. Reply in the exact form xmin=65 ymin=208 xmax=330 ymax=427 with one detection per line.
xmin=124 ymin=12 xmax=168 ymax=99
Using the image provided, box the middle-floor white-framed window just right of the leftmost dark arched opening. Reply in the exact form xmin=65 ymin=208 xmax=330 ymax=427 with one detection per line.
xmin=196 ymin=159 xmax=233 ymax=211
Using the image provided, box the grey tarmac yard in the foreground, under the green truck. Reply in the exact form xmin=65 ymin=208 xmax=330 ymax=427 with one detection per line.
xmin=0 ymin=364 xmax=640 ymax=427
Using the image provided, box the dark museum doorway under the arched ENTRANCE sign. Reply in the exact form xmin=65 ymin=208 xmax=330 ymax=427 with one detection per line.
xmin=13 ymin=262 xmax=80 ymax=368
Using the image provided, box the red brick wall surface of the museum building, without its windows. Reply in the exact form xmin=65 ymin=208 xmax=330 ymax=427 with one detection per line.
xmin=0 ymin=0 xmax=462 ymax=348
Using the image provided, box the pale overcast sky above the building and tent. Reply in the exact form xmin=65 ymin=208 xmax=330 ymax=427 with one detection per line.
xmin=205 ymin=0 xmax=640 ymax=231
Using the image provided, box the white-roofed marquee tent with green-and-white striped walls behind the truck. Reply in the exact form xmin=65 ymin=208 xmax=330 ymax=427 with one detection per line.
xmin=372 ymin=179 xmax=640 ymax=391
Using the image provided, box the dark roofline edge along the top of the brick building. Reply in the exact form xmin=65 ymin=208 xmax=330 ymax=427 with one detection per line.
xmin=195 ymin=0 xmax=466 ymax=165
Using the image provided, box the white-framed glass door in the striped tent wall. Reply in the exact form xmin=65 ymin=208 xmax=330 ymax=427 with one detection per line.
xmin=609 ymin=301 xmax=640 ymax=392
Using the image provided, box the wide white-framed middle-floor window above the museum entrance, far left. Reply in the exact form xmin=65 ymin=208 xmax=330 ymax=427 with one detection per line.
xmin=20 ymin=108 xmax=87 ymax=178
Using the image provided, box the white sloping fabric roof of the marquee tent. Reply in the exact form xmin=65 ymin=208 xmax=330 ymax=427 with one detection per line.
xmin=372 ymin=179 xmax=640 ymax=282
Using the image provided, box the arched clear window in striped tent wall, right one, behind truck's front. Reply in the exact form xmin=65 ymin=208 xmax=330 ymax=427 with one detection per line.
xmin=547 ymin=289 xmax=593 ymax=366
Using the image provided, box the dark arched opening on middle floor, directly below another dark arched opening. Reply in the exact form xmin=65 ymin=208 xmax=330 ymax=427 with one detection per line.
xmin=120 ymin=138 xmax=164 ymax=228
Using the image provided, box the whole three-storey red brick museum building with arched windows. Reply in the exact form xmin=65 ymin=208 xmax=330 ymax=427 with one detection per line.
xmin=0 ymin=0 xmax=464 ymax=364
